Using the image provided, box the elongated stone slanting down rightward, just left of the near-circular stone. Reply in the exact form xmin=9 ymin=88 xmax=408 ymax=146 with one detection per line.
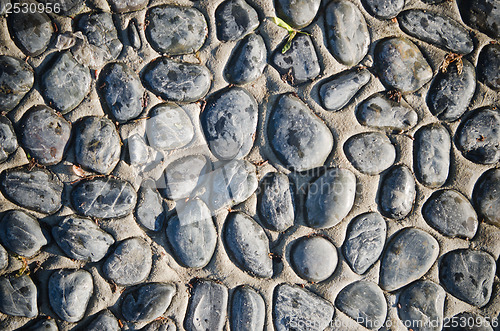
xmin=224 ymin=213 xmax=273 ymax=278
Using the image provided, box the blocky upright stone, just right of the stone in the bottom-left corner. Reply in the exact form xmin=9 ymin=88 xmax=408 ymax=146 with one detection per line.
xmin=49 ymin=269 xmax=94 ymax=323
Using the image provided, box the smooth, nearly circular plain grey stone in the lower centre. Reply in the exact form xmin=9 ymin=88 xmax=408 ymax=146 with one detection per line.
xmin=290 ymin=236 xmax=338 ymax=283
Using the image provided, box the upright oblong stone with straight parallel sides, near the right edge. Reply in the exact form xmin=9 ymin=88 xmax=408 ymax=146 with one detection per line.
xmin=413 ymin=123 xmax=451 ymax=188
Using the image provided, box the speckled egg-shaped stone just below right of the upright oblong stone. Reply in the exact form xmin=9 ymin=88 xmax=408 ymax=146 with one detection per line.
xmin=422 ymin=190 xmax=478 ymax=239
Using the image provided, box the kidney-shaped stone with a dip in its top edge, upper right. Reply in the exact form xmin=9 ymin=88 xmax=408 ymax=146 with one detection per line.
xmin=356 ymin=93 xmax=418 ymax=131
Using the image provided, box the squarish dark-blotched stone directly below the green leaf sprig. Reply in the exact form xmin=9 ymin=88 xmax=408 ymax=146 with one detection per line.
xmin=273 ymin=34 xmax=321 ymax=85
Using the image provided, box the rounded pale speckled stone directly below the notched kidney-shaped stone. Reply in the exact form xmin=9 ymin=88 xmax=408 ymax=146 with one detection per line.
xmin=344 ymin=132 xmax=396 ymax=175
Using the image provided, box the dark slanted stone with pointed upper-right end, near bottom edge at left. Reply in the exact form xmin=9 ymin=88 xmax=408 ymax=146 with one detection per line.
xmin=122 ymin=283 xmax=175 ymax=322
